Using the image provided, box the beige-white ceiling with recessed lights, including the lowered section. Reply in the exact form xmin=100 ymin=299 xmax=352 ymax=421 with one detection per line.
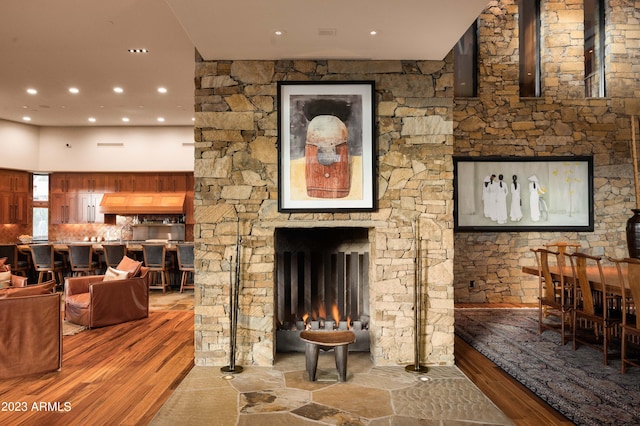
xmin=0 ymin=0 xmax=488 ymax=126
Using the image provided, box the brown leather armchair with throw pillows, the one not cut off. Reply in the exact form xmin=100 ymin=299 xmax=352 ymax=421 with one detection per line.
xmin=64 ymin=267 xmax=149 ymax=328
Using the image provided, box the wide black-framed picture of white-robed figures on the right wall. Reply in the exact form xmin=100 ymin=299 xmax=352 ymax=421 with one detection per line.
xmin=453 ymin=156 xmax=593 ymax=232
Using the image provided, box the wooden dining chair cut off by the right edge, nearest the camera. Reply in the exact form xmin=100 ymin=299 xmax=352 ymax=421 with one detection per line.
xmin=609 ymin=257 xmax=640 ymax=374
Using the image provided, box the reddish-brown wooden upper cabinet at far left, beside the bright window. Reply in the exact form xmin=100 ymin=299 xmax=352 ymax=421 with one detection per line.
xmin=0 ymin=170 xmax=31 ymax=225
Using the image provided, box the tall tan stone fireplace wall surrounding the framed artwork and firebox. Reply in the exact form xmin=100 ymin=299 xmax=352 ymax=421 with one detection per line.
xmin=194 ymin=58 xmax=454 ymax=366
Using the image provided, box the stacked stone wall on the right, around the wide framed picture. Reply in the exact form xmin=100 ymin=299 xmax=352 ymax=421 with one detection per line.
xmin=454 ymin=0 xmax=640 ymax=303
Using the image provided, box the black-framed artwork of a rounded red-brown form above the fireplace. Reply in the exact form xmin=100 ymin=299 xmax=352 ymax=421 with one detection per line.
xmin=278 ymin=81 xmax=376 ymax=212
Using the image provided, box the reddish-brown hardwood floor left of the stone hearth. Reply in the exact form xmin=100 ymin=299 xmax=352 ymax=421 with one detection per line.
xmin=0 ymin=311 xmax=194 ymax=425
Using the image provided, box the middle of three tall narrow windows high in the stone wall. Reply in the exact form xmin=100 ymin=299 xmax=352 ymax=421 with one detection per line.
xmin=518 ymin=0 xmax=540 ymax=97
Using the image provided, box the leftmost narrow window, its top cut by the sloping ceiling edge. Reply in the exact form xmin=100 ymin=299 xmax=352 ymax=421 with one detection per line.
xmin=453 ymin=21 xmax=478 ymax=97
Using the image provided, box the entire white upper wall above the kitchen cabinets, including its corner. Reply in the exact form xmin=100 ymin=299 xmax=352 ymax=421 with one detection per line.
xmin=0 ymin=121 xmax=194 ymax=172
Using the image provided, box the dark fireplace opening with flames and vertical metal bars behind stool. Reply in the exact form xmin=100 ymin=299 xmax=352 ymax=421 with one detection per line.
xmin=276 ymin=228 xmax=369 ymax=352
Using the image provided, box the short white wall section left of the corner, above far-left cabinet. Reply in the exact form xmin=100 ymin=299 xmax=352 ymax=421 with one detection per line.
xmin=0 ymin=120 xmax=40 ymax=171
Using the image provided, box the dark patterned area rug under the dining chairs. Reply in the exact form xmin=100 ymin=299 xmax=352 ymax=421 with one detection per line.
xmin=455 ymin=309 xmax=640 ymax=425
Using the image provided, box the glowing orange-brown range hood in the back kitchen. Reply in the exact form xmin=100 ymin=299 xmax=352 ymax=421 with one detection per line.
xmin=100 ymin=192 xmax=186 ymax=215
